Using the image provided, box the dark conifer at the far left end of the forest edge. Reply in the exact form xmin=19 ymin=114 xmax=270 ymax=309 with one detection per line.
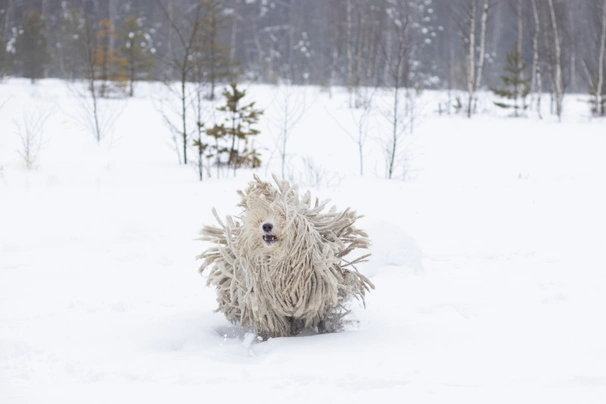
xmin=14 ymin=10 xmax=50 ymax=82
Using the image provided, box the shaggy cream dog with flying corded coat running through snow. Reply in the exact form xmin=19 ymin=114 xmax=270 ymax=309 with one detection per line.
xmin=198 ymin=175 xmax=374 ymax=338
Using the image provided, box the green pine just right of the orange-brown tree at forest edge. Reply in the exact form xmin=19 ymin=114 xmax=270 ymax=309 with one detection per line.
xmin=119 ymin=15 xmax=155 ymax=97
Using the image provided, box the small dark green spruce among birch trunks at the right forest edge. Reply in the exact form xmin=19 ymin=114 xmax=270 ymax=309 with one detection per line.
xmin=491 ymin=50 xmax=531 ymax=116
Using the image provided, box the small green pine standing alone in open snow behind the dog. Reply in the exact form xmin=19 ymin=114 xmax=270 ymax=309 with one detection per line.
xmin=206 ymin=82 xmax=263 ymax=175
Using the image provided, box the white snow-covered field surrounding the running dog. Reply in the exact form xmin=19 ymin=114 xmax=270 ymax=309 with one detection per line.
xmin=0 ymin=79 xmax=606 ymax=404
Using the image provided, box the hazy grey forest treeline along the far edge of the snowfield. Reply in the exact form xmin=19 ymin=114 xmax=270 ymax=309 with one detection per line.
xmin=0 ymin=0 xmax=606 ymax=116
